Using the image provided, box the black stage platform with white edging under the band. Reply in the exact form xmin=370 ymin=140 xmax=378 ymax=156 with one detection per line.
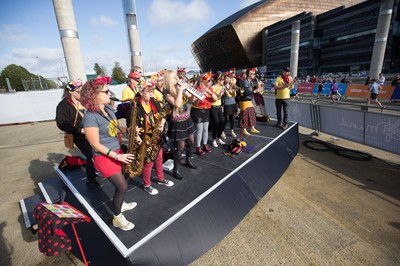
xmin=20 ymin=123 xmax=299 ymax=265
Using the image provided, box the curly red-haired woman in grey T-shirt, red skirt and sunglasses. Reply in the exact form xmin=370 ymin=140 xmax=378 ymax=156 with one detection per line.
xmin=81 ymin=77 xmax=137 ymax=231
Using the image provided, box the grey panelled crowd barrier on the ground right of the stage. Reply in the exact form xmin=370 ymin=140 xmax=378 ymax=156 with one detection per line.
xmin=264 ymin=96 xmax=400 ymax=154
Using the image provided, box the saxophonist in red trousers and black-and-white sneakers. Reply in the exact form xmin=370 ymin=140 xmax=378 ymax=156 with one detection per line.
xmin=136 ymin=79 xmax=174 ymax=195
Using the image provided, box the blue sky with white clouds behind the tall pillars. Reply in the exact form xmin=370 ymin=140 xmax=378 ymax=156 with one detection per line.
xmin=0 ymin=0 xmax=258 ymax=79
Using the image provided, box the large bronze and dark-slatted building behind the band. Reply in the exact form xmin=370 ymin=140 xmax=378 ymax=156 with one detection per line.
xmin=191 ymin=0 xmax=400 ymax=74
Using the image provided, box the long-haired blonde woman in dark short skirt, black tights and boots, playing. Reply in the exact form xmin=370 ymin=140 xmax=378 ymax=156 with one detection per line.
xmin=164 ymin=70 xmax=197 ymax=179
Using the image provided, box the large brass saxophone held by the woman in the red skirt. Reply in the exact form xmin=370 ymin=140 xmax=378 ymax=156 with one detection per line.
xmin=123 ymin=101 xmax=146 ymax=178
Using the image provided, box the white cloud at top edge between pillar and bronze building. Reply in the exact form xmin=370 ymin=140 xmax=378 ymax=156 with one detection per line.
xmin=148 ymin=0 xmax=211 ymax=32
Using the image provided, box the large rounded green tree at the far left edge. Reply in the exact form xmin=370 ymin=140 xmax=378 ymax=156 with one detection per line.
xmin=0 ymin=64 xmax=37 ymax=91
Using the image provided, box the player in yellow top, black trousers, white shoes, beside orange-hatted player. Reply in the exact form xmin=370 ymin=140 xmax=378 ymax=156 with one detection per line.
xmin=210 ymin=74 xmax=226 ymax=148
